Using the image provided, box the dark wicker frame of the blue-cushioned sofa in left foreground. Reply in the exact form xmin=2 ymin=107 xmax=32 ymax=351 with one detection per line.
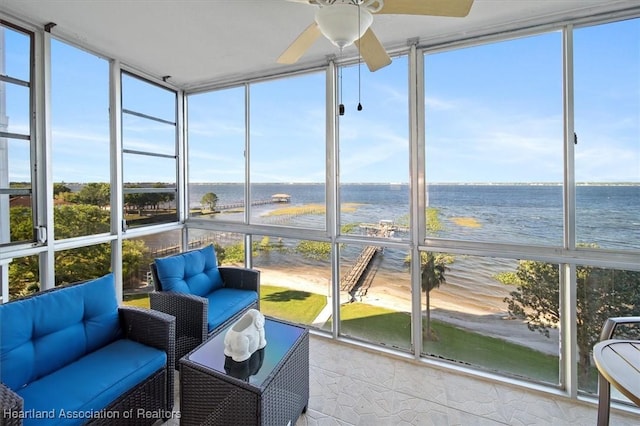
xmin=0 ymin=282 xmax=176 ymax=426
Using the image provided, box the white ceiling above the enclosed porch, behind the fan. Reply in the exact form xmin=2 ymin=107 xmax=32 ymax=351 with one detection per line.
xmin=0 ymin=0 xmax=640 ymax=89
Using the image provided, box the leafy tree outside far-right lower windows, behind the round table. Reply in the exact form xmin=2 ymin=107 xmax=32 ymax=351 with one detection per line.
xmin=501 ymin=260 xmax=640 ymax=378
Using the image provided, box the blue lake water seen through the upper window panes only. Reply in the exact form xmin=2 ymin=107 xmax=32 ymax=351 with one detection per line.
xmin=190 ymin=184 xmax=640 ymax=250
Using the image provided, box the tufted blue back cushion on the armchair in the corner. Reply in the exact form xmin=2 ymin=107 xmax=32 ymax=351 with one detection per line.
xmin=154 ymin=245 xmax=223 ymax=297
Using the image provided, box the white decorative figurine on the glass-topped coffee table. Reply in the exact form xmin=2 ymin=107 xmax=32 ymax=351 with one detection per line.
xmin=224 ymin=309 xmax=267 ymax=362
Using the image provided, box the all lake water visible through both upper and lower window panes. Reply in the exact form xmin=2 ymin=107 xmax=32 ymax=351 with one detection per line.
xmin=185 ymin=184 xmax=640 ymax=330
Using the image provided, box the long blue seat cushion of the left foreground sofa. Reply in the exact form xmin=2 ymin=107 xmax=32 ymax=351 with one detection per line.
xmin=17 ymin=339 xmax=167 ymax=426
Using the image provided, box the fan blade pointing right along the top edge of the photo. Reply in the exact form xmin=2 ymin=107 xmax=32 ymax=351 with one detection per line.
xmin=376 ymin=0 xmax=473 ymax=18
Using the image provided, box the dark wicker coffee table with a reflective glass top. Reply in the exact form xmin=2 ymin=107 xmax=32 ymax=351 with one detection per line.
xmin=180 ymin=318 xmax=309 ymax=426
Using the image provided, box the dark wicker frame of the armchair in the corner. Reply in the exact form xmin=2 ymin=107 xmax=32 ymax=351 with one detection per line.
xmin=149 ymin=263 xmax=260 ymax=367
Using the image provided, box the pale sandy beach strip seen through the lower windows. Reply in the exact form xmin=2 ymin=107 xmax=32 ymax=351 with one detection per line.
xmin=257 ymin=266 xmax=559 ymax=355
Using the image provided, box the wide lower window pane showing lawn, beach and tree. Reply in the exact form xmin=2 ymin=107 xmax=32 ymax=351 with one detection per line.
xmin=421 ymin=252 xmax=560 ymax=384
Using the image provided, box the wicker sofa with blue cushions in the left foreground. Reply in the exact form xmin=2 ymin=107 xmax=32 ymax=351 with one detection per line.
xmin=0 ymin=274 xmax=175 ymax=425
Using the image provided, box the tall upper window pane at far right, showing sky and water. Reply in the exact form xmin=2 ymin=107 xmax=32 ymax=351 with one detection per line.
xmin=574 ymin=19 xmax=640 ymax=250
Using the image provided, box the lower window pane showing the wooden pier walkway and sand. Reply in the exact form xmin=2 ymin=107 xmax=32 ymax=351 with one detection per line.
xmin=338 ymin=244 xmax=412 ymax=350
